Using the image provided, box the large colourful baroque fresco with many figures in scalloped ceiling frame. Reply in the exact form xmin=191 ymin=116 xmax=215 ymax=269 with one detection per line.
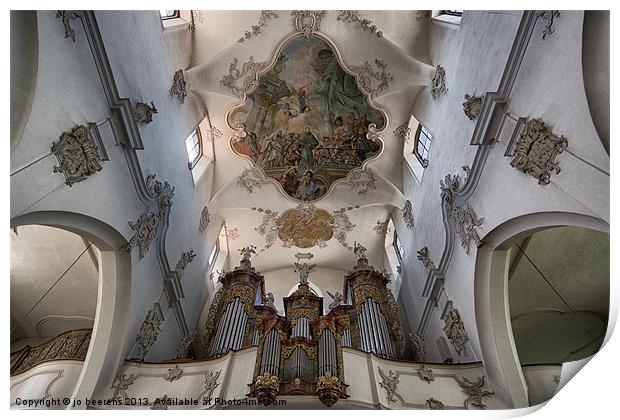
xmin=227 ymin=35 xmax=386 ymax=201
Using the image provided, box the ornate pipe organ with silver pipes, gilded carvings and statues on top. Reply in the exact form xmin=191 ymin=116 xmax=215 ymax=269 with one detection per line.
xmin=204 ymin=244 xmax=402 ymax=407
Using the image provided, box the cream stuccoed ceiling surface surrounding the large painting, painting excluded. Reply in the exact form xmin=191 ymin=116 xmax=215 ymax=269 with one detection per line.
xmin=184 ymin=11 xmax=434 ymax=287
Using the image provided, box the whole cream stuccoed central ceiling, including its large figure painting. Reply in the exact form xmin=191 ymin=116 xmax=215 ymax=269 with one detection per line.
xmin=185 ymin=10 xmax=434 ymax=281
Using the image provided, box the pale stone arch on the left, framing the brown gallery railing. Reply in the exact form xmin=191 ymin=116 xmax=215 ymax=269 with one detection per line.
xmin=11 ymin=211 xmax=131 ymax=407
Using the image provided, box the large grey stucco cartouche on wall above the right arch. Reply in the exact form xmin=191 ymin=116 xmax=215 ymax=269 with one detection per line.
xmin=510 ymin=118 xmax=568 ymax=185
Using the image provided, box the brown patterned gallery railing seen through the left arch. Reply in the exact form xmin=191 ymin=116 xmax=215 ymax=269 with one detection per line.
xmin=11 ymin=329 xmax=92 ymax=376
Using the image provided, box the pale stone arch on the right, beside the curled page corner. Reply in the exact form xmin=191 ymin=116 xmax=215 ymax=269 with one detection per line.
xmin=474 ymin=212 xmax=613 ymax=408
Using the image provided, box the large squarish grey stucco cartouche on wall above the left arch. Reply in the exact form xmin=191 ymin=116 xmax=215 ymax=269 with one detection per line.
xmin=51 ymin=125 xmax=103 ymax=186
